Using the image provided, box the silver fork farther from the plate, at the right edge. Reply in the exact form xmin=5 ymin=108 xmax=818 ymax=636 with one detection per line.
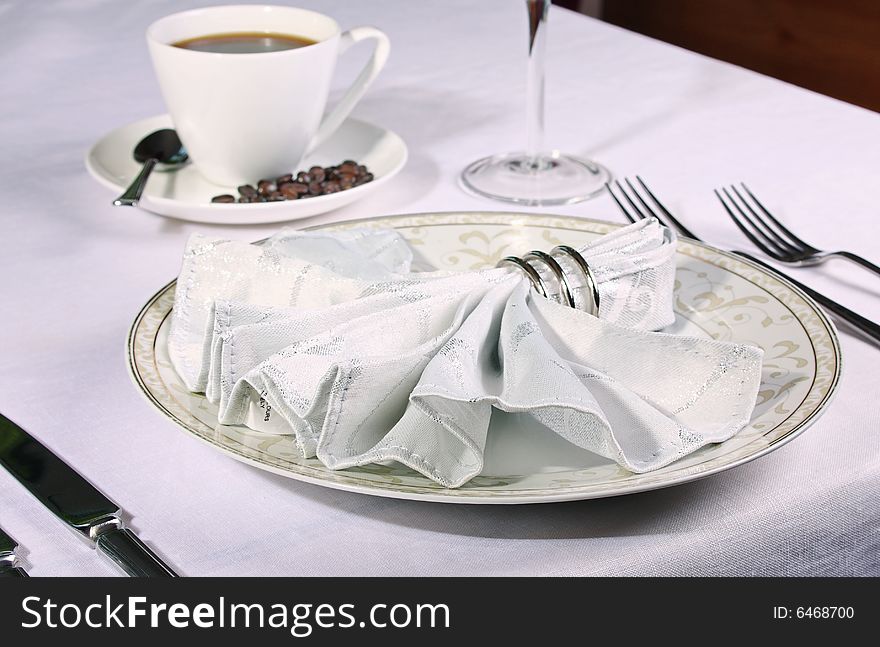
xmin=715 ymin=182 xmax=880 ymax=275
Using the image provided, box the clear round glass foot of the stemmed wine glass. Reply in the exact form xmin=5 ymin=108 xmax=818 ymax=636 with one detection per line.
xmin=461 ymin=151 xmax=611 ymax=206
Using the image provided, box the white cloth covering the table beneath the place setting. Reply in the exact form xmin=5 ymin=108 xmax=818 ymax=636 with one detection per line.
xmin=0 ymin=0 xmax=880 ymax=575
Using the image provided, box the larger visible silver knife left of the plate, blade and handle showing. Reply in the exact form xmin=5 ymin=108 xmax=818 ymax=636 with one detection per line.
xmin=0 ymin=415 xmax=177 ymax=577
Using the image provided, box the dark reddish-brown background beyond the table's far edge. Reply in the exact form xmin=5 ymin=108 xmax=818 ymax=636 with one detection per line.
xmin=556 ymin=0 xmax=880 ymax=111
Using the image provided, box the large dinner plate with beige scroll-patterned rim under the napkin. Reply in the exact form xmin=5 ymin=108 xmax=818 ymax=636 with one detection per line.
xmin=128 ymin=213 xmax=841 ymax=504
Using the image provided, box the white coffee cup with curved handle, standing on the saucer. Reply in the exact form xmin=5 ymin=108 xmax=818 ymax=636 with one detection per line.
xmin=147 ymin=5 xmax=390 ymax=186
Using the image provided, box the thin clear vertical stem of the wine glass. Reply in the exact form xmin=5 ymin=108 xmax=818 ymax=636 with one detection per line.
xmin=526 ymin=0 xmax=550 ymax=170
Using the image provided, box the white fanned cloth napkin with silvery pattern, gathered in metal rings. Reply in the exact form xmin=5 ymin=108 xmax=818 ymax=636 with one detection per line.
xmin=168 ymin=220 xmax=762 ymax=487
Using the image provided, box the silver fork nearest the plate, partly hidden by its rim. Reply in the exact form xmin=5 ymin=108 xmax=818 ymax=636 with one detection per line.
xmin=605 ymin=175 xmax=880 ymax=344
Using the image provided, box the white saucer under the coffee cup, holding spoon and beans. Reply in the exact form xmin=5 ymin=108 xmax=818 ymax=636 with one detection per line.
xmin=86 ymin=115 xmax=407 ymax=225
